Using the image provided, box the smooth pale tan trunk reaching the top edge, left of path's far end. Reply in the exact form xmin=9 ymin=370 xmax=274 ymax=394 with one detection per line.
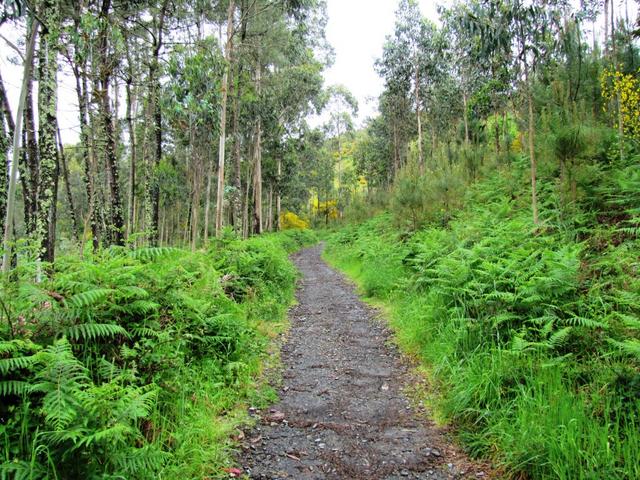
xmin=216 ymin=0 xmax=235 ymax=237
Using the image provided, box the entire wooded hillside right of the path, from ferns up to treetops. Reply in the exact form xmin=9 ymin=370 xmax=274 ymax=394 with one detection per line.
xmin=326 ymin=0 xmax=640 ymax=480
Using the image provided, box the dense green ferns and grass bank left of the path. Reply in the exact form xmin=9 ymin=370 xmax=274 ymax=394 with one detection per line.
xmin=0 ymin=231 xmax=315 ymax=479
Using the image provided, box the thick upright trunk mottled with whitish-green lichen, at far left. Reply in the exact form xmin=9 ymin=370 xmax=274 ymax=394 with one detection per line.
xmin=34 ymin=0 xmax=59 ymax=262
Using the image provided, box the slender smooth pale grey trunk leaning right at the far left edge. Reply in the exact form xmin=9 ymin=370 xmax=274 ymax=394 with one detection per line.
xmin=2 ymin=20 xmax=39 ymax=273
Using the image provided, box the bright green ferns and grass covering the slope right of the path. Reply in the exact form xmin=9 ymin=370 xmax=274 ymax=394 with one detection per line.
xmin=326 ymin=155 xmax=640 ymax=480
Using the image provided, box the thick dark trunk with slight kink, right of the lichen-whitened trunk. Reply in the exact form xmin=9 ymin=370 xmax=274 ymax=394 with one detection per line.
xmin=96 ymin=0 xmax=124 ymax=245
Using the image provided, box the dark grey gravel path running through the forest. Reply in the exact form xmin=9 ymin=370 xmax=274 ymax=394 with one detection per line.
xmin=240 ymin=246 xmax=488 ymax=480
